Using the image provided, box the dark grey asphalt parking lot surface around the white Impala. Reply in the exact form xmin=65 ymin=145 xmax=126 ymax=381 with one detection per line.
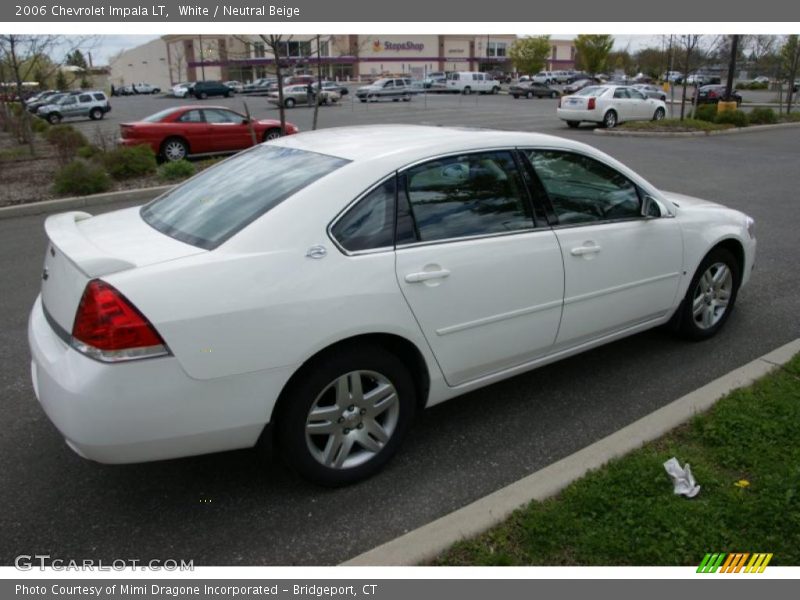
xmin=0 ymin=91 xmax=800 ymax=565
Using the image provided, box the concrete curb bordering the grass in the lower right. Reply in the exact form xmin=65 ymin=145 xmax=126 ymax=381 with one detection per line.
xmin=342 ymin=338 xmax=800 ymax=566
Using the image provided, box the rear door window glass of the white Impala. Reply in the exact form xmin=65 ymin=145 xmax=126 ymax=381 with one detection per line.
xmin=401 ymin=151 xmax=533 ymax=242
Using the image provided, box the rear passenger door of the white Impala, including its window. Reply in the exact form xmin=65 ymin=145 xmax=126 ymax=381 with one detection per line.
xmin=395 ymin=150 xmax=564 ymax=386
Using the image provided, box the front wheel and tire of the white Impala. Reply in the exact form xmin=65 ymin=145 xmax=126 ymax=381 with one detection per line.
xmin=670 ymin=247 xmax=741 ymax=341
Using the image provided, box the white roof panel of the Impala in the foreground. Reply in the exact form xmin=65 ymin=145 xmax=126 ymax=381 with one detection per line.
xmin=273 ymin=125 xmax=588 ymax=165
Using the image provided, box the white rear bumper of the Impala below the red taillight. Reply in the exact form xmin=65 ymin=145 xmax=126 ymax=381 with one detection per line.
xmin=28 ymin=298 xmax=290 ymax=463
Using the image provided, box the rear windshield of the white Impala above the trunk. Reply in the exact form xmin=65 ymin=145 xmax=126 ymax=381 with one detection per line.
xmin=141 ymin=145 xmax=349 ymax=250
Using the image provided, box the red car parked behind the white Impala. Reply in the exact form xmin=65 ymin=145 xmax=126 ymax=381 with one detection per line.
xmin=120 ymin=105 xmax=300 ymax=161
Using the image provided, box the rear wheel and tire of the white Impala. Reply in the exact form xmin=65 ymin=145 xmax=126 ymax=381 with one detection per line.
xmin=275 ymin=345 xmax=416 ymax=487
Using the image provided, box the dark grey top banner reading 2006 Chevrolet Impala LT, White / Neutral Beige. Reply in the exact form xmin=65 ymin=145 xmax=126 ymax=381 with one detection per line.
xmin=0 ymin=0 xmax=800 ymax=22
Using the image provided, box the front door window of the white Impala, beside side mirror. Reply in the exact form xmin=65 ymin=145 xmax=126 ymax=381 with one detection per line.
xmin=526 ymin=150 xmax=641 ymax=225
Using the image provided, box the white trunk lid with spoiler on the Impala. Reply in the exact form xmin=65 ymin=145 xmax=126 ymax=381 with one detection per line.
xmin=41 ymin=207 xmax=207 ymax=332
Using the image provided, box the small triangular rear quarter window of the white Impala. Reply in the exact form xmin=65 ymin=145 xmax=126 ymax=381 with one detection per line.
xmin=331 ymin=177 xmax=397 ymax=252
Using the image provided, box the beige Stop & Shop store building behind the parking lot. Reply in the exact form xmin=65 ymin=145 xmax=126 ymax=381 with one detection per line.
xmin=110 ymin=34 xmax=575 ymax=89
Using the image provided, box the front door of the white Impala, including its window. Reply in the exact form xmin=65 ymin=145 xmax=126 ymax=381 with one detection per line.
xmin=525 ymin=150 xmax=683 ymax=348
